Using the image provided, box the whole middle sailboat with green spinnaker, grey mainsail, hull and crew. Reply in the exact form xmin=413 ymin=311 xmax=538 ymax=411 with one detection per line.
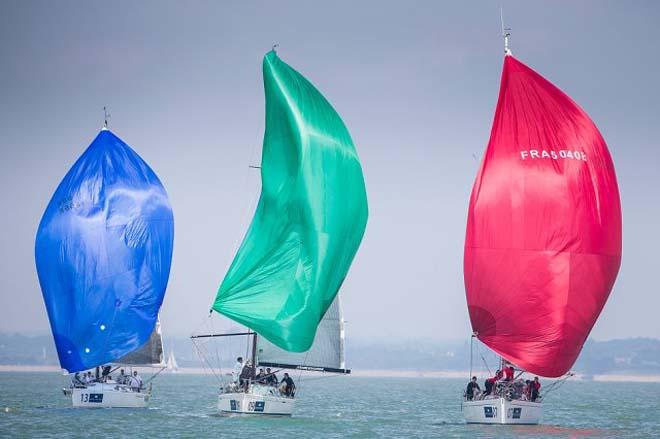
xmin=192 ymin=50 xmax=367 ymax=415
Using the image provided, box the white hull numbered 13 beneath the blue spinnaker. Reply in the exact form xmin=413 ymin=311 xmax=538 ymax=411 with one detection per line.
xmin=71 ymin=383 xmax=151 ymax=408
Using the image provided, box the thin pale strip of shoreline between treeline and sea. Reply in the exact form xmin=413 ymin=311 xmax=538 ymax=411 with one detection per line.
xmin=0 ymin=365 xmax=660 ymax=383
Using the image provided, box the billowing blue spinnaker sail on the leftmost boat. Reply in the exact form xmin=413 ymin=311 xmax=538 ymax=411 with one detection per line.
xmin=35 ymin=129 xmax=174 ymax=372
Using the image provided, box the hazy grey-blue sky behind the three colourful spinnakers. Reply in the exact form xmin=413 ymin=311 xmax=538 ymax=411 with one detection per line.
xmin=0 ymin=0 xmax=660 ymax=339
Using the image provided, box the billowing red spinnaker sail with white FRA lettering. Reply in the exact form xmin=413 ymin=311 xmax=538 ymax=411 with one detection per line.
xmin=464 ymin=55 xmax=621 ymax=377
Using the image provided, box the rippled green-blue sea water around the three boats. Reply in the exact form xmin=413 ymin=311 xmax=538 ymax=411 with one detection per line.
xmin=0 ymin=373 xmax=660 ymax=439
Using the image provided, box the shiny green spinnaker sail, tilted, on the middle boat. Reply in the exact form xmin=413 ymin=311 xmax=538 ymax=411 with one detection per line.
xmin=213 ymin=52 xmax=368 ymax=352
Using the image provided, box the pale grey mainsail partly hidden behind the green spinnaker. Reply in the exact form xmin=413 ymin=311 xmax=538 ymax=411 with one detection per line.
xmin=257 ymin=295 xmax=349 ymax=373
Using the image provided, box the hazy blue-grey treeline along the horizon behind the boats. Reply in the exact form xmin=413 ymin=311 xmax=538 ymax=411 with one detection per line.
xmin=0 ymin=333 xmax=660 ymax=375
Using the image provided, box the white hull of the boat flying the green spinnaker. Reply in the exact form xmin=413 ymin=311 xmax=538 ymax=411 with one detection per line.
xmin=218 ymin=385 xmax=296 ymax=416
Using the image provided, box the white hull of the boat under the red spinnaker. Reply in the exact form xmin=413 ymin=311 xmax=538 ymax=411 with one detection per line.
xmin=463 ymin=398 xmax=543 ymax=425
